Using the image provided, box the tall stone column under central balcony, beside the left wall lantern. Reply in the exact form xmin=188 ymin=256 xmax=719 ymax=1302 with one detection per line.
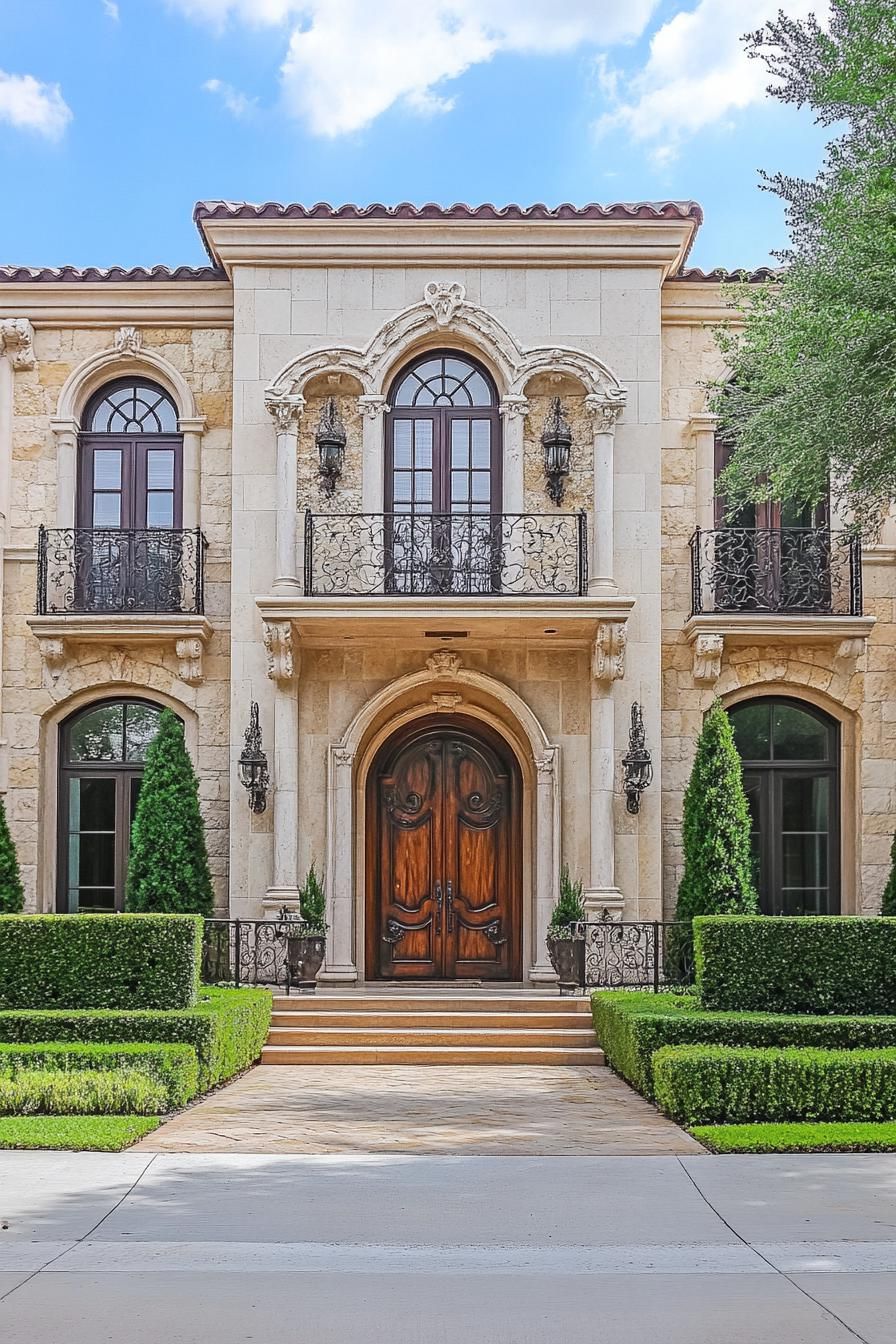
xmin=263 ymin=621 xmax=300 ymax=914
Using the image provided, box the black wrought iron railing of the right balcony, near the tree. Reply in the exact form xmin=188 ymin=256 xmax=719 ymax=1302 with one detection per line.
xmin=690 ymin=527 xmax=862 ymax=616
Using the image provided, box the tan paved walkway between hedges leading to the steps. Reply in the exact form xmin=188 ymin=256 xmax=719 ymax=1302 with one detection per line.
xmin=138 ymin=1066 xmax=703 ymax=1157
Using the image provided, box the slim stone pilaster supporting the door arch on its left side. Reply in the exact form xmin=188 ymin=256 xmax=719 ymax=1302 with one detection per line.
xmin=320 ymin=746 xmax=357 ymax=985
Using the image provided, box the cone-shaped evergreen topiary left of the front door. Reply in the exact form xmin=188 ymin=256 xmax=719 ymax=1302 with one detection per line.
xmin=125 ymin=710 xmax=214 ymax=915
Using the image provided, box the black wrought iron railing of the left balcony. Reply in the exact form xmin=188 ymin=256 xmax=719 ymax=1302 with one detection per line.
xmin=38 ymin=527 xmax=206 ymax=616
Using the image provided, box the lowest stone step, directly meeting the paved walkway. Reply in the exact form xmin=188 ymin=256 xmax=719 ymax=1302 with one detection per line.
xmin=261 ymin=1044 xmax=603 ymax=1067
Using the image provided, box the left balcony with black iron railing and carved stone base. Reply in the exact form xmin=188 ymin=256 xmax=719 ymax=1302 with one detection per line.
xmin=28 ymin=527 xmax=211 ymax=685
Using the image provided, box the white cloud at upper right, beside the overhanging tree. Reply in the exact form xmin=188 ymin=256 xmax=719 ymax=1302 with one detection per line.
xmin=596 ymin=0 xmax=818 ymax=167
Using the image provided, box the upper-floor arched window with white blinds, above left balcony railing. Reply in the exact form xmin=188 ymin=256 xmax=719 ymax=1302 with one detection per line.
xmin=78 ymin=378 xmax=183 ymax=531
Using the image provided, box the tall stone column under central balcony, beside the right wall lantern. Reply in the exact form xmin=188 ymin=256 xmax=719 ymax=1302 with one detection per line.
xmin=584 ymin=621 xmax=626 ymax=919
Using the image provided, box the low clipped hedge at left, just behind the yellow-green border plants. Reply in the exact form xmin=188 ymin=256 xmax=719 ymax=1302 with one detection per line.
xmin=0 ymin=1040 xmax=199 ymax=1116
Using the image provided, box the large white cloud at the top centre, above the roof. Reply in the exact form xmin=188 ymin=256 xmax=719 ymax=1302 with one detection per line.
xmin=169 ymin=0 xmax=658 ymax=136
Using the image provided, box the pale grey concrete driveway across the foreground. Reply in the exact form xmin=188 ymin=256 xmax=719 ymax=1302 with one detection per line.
xmin=0 ymin=1152 xmax=896 ymax=1344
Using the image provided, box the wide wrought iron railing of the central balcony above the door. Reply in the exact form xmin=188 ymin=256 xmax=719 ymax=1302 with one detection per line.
xmin=305 ymin=512 xmax=588 ymax=597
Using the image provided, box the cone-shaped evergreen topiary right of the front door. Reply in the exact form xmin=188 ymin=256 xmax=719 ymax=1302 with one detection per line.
xmin=670 ymin=700 xmax=759 ymax=960
